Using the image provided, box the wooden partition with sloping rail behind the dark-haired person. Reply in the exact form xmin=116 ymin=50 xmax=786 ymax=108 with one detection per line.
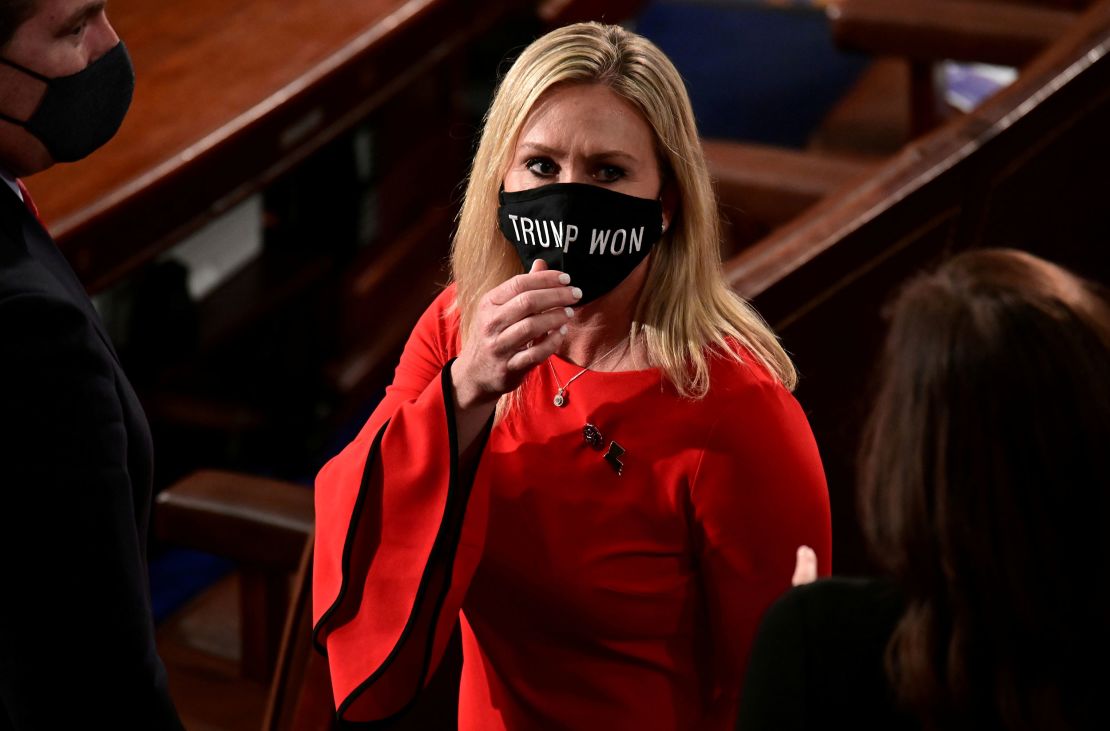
xmin=727 ymin=0 xmax=1110 ymax=572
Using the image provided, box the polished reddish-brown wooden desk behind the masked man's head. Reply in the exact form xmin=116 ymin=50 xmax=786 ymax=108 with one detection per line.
xmin=29 ymin=0 xmax=525 ymax=290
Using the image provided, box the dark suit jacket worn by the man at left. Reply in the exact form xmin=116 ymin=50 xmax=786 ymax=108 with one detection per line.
xmin=0 ymin=189 xmax=181 ymax=731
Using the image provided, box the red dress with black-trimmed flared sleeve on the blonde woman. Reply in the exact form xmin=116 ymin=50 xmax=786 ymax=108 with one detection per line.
xmin=313 ymin=287 xmax=831 ymax=731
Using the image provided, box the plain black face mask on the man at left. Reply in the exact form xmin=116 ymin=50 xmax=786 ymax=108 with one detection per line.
xmin=0 ymin=41 xmax=135 ymax=162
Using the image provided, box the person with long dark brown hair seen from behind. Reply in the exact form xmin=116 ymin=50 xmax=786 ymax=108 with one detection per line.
xmin=738 ymin=250 xmax=1110 ymax=731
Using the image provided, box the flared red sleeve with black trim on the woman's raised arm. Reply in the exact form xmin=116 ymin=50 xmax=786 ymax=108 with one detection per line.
xmin=313 ymin=287 xmax=488 ymax=721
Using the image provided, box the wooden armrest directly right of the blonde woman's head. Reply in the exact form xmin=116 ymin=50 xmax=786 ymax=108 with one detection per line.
xmin=702 ymin=140 xmax=878 ymax=227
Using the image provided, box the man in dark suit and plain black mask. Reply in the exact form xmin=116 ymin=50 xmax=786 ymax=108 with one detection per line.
xmin=0 ymin=0 xmax=181 ymax=731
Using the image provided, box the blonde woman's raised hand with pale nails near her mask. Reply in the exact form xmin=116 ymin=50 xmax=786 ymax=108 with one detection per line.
xmin=451 ymin=260 xmax=582 ymax=409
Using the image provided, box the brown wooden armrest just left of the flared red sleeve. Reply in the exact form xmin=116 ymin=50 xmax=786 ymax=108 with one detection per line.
xmin=154 ymin=470 xmax=313 ymax=570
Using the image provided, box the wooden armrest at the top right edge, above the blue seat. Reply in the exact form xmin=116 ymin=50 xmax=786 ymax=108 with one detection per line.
xmin=827 ymin=0 xmax=1078 ymax=67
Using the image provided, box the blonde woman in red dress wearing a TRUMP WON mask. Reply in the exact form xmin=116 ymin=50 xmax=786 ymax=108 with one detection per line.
xmin=314 ymin=23 xmax=830 ymax=730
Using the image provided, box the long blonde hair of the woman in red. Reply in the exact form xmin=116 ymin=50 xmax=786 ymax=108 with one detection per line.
xmin=452 ymin=22 xmax=797 ymax=398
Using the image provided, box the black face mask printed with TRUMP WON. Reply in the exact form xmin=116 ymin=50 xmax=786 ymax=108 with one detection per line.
xmin=497 ymin=183 xmax=663 ymax=305
